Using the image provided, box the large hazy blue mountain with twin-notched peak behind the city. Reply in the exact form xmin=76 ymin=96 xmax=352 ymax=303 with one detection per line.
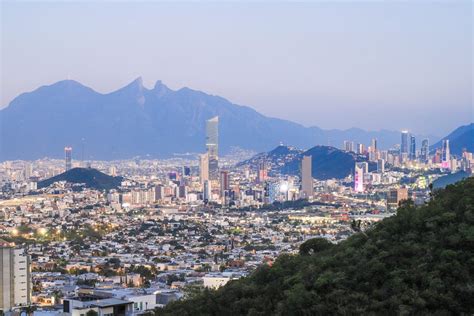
xmin=0 ymin=78 xmax=436 ymax=160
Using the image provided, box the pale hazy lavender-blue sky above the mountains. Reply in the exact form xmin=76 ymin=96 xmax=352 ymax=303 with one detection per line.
xmin=0 ymin=0 xmax=474 ymax=136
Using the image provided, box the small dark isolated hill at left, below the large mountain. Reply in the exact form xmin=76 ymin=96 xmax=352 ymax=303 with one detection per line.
xmin=38 ymin=168 xmax=123 ymax=190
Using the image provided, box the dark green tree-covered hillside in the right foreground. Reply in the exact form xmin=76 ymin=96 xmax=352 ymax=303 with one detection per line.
xmin=157 ymin=178 xmax=474 ymax=316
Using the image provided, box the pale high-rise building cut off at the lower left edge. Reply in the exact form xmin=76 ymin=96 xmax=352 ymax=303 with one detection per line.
xmin=0 ymin=244 xmax=31 ymax=312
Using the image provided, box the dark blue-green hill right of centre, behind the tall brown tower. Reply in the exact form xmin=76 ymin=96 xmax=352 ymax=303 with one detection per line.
xmin=282 ymin=146 xmax=376 ymax=180
